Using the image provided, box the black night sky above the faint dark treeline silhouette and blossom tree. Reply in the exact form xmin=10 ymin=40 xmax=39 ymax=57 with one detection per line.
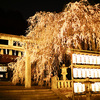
xmin=0 ymin=0 xmax=70 ymax=19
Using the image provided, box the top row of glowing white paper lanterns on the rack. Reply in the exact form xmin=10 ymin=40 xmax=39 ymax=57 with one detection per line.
xmin=72 ymin=54 xmax=100 ymax=65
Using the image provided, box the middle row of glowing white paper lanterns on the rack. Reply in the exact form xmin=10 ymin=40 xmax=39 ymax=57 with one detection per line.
xmin=73 ymin=68 xmax=100 ymax=78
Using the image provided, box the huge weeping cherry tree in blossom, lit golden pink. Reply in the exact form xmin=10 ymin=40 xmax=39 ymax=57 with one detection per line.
xmin=9 ymin=1 xmax=100 ymax=84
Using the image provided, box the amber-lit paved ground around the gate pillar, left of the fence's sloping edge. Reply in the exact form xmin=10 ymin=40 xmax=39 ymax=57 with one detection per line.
xmin=0 ymin=81 xmax=61 ymax=100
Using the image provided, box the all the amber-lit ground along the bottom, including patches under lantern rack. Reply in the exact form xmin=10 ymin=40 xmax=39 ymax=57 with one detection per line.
xmin=0 ymin=81 xmax=100 ymax=100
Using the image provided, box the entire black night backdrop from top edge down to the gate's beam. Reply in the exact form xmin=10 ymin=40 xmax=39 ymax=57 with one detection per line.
xmin=0 ymin=0 xmax=100 ymax=35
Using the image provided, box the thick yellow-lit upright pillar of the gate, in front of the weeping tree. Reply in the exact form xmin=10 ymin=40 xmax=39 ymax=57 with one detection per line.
xmin=25 ymin=49 xmax=31 ymax=88
